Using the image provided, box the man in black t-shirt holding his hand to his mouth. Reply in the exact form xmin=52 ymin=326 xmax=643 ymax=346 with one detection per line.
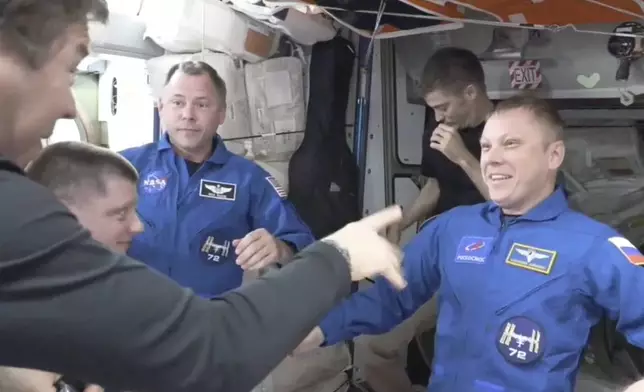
xmin=363 ymin=47 xmax=494 ymax=392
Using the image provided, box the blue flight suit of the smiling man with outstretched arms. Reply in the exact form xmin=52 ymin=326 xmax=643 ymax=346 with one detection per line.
xmin=320 ymin=189 xmax=644 ymax=392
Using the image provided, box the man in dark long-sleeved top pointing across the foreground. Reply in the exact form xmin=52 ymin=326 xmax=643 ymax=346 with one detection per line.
xmin=0 ymin=0 xmax=404 ymax=392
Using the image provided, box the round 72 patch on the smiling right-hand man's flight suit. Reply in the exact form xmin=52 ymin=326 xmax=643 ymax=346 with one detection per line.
xmin=496 ymin=316 xmax=545 ymax=365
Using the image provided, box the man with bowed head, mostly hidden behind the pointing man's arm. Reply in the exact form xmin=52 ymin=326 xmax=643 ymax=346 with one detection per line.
xmin=0 ymin=142 xmax=143 ymax=392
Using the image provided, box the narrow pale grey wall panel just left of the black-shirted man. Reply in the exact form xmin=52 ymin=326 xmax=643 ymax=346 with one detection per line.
xmin=395 ymin=55 xmax=426 ymax=165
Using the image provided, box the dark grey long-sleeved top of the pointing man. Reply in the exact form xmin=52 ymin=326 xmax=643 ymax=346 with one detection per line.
xmin=0 ymin=172 xmax=350 ymax=392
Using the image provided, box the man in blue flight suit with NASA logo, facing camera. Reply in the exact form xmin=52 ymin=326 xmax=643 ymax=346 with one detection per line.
xmin=122 ymin=62 xmax=314 ymax=298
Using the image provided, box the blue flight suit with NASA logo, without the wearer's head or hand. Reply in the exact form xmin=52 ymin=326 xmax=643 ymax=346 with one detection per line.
xmin=121 ymin=135 xmax=314 ymax=298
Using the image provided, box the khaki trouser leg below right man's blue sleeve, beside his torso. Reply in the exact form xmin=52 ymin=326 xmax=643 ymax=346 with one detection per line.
xmin=357 ymin=297 xmax=437 ymax=392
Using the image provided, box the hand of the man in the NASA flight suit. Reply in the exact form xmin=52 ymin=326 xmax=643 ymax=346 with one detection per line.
xmin=233 ymin=228 xmax=288 ymax=271
